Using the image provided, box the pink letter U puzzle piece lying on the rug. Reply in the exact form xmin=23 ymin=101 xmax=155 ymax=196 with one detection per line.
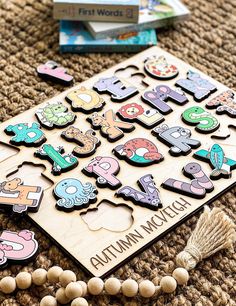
xmin=0 ymin=230 xmax=38 ymax=268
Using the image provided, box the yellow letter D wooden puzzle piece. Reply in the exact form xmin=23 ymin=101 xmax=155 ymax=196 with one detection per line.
xmin=65 ymin=86 xmax=105 ymax=114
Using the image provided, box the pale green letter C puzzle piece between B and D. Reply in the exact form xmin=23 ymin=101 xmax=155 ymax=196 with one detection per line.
xmin=35 ymin=102 xmax=76 ymax=129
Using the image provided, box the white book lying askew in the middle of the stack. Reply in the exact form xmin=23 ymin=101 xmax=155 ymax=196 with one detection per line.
xmin=85 ymin=0 xmax=190 ymax=39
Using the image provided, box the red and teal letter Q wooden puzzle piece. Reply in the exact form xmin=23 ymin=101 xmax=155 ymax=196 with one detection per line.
xmin=112 ymin=138 xmax=163 ymax=166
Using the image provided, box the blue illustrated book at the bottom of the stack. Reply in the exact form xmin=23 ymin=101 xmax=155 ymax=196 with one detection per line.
xmin=59 ymin=20 xmax=157 ymax=53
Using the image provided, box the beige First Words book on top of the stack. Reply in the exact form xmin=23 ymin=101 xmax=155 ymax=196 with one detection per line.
xmin=53 ymin=0 xmax=139 ymax=23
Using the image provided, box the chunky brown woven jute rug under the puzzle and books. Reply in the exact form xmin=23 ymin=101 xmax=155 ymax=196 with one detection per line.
xmin=0 ymin=0 xmax=236 ymax=306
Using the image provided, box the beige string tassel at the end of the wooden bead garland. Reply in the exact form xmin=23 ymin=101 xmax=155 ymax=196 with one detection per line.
xmin=176 ymin=206 xmax=236 ymax=270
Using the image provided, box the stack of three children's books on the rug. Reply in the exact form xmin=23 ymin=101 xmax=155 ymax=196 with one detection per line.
xmin=53 ymin=0 xmax=189 ymax=53
